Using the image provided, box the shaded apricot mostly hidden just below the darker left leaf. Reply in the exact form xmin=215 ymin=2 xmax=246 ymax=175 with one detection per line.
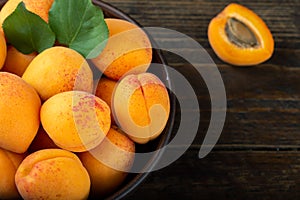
xmin=2 ymin=45 xmax=37 ymax=76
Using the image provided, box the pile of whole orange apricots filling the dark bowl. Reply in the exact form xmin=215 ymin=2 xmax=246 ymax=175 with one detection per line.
xmin=0 ymin=0 xmax=170 ymax=199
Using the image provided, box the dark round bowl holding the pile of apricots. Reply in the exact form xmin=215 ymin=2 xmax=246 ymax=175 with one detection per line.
xmin=0 ymin=0 xmax=175 ymax=199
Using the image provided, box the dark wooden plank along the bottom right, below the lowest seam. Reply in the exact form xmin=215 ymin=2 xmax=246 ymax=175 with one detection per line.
xmin=125 ymin=150 xmax=300 ymax=200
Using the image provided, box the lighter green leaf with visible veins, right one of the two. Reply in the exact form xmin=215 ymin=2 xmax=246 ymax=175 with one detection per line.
xmin=49 ymin=0 xmax=108 ymax=59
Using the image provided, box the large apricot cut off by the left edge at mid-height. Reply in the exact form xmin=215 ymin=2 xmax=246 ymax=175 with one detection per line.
xmin=0 ymin=72 xmax=41 ymax=153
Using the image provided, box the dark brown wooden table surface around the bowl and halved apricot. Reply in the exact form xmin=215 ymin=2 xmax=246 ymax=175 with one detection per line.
xmin=106 ymin=0 xmax=300 ymax=199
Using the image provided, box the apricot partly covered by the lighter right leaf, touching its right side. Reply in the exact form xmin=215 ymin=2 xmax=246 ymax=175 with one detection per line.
xmin=92 ymin=18 xmax=152 ymax=80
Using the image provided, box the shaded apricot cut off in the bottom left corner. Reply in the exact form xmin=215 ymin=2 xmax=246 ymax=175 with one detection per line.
xmin=0 ymin=148 xmax=25 ymax=199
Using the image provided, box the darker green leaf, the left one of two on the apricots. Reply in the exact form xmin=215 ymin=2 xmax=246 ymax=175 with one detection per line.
xmin=2 ymin=2 xmax=55 ymax=54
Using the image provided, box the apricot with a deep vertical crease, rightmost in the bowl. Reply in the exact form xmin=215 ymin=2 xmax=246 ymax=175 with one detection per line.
xmin=113 ymin=73 xmax=169 ymax=144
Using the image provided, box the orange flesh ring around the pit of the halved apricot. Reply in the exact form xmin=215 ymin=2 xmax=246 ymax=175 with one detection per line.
xmin=208 ymin=3 xmax=274 ymax=66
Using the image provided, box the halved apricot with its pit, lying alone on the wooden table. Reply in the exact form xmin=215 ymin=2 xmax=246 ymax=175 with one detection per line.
xmin=208 ymin=3 xmax=274 ymax=66
